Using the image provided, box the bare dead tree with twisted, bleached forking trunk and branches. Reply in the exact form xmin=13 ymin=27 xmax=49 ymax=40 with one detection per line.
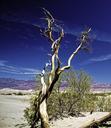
xmin=31 ymin=8 xmax=91 ymax=128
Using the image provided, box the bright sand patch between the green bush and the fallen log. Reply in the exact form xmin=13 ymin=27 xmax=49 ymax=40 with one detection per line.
xmin=52 ymin=112 xmax=109 ymax=128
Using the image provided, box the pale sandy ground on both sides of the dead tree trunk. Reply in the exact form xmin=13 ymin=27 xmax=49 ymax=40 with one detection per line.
xmin=0 ymin=91 xmax=108 ymax=128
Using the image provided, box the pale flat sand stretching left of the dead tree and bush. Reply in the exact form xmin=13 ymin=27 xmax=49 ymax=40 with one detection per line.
xmin=0 ymin=95 xmax=28 ymax=128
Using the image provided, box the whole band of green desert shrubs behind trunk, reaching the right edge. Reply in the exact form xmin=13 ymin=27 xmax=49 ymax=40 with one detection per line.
xmin=25 ymin=71 xmax=111 ymax=128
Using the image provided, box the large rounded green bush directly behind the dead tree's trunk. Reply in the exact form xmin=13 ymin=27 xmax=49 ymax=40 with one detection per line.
xmin=25 ymin=71 xmax=94 ymax=125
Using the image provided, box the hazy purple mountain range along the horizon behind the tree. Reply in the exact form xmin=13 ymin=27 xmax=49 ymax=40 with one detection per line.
xmin=0 ymin=78 xmax=111 ymax=90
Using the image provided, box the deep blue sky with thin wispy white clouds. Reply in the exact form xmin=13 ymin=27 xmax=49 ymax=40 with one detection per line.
xmin=0 ymin=0 xmax=111 ymax=83
